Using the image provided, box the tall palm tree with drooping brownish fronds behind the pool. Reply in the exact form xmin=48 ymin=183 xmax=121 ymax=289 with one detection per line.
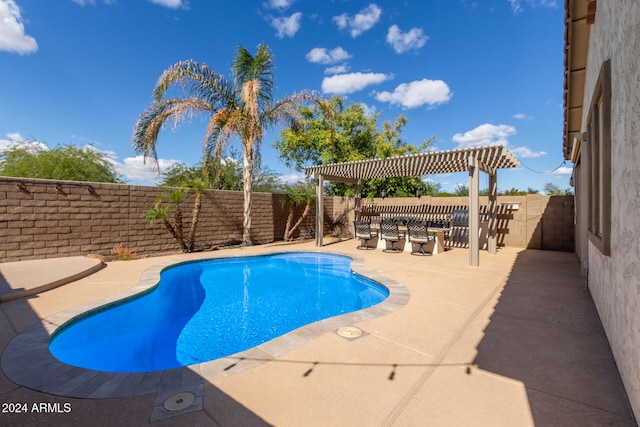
xmin=133 ymin=45 xmax=330 ymax=245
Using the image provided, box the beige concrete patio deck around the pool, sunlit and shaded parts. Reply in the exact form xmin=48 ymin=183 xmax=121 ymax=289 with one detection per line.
xmin=0 ymin=240 xmax=636 ymax=426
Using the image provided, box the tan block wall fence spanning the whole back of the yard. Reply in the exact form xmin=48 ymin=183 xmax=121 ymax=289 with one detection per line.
xmin=0 ymin=177 xmax=574 ymax=262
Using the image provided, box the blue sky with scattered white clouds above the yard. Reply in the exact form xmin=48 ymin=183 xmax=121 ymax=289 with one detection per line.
xmin=0 ymin=0 xmax=571 ymax=190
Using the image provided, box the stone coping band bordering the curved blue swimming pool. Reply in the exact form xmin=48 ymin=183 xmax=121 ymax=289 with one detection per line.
xmin=0 ymin=249 xmax=410 ymax=421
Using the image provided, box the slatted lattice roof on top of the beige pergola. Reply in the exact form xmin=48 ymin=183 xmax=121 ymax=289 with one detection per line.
xmin=304 ymin=145 xmax=520 ymax=182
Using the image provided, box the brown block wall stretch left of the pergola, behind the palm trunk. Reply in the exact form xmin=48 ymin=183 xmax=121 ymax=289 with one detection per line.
xmin=0 ymin=177 xmax=302 ymax=262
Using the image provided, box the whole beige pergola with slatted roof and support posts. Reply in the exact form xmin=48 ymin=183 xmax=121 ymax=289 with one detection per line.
xmin=304 ymin=145 xmax=520 ymax=266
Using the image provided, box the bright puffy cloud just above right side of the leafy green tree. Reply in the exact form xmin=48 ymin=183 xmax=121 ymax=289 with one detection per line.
xmin=376 ymin=79 xmax=453 ymax=108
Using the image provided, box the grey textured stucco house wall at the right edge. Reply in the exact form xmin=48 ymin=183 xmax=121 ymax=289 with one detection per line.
xmin=576 ymin=0 xmax=640 ymax=419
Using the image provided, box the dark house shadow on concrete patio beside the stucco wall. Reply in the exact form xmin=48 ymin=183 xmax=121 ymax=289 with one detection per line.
xmin=474 ymin=250 xmax=636 ymax=426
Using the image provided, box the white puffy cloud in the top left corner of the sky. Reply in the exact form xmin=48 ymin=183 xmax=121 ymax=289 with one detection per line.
xmin=0 ymin=0 xmax=38 ymax=55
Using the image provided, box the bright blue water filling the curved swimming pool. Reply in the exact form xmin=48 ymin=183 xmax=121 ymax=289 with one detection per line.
xmin=49 ymin=253 xmax=389 ymax=372
